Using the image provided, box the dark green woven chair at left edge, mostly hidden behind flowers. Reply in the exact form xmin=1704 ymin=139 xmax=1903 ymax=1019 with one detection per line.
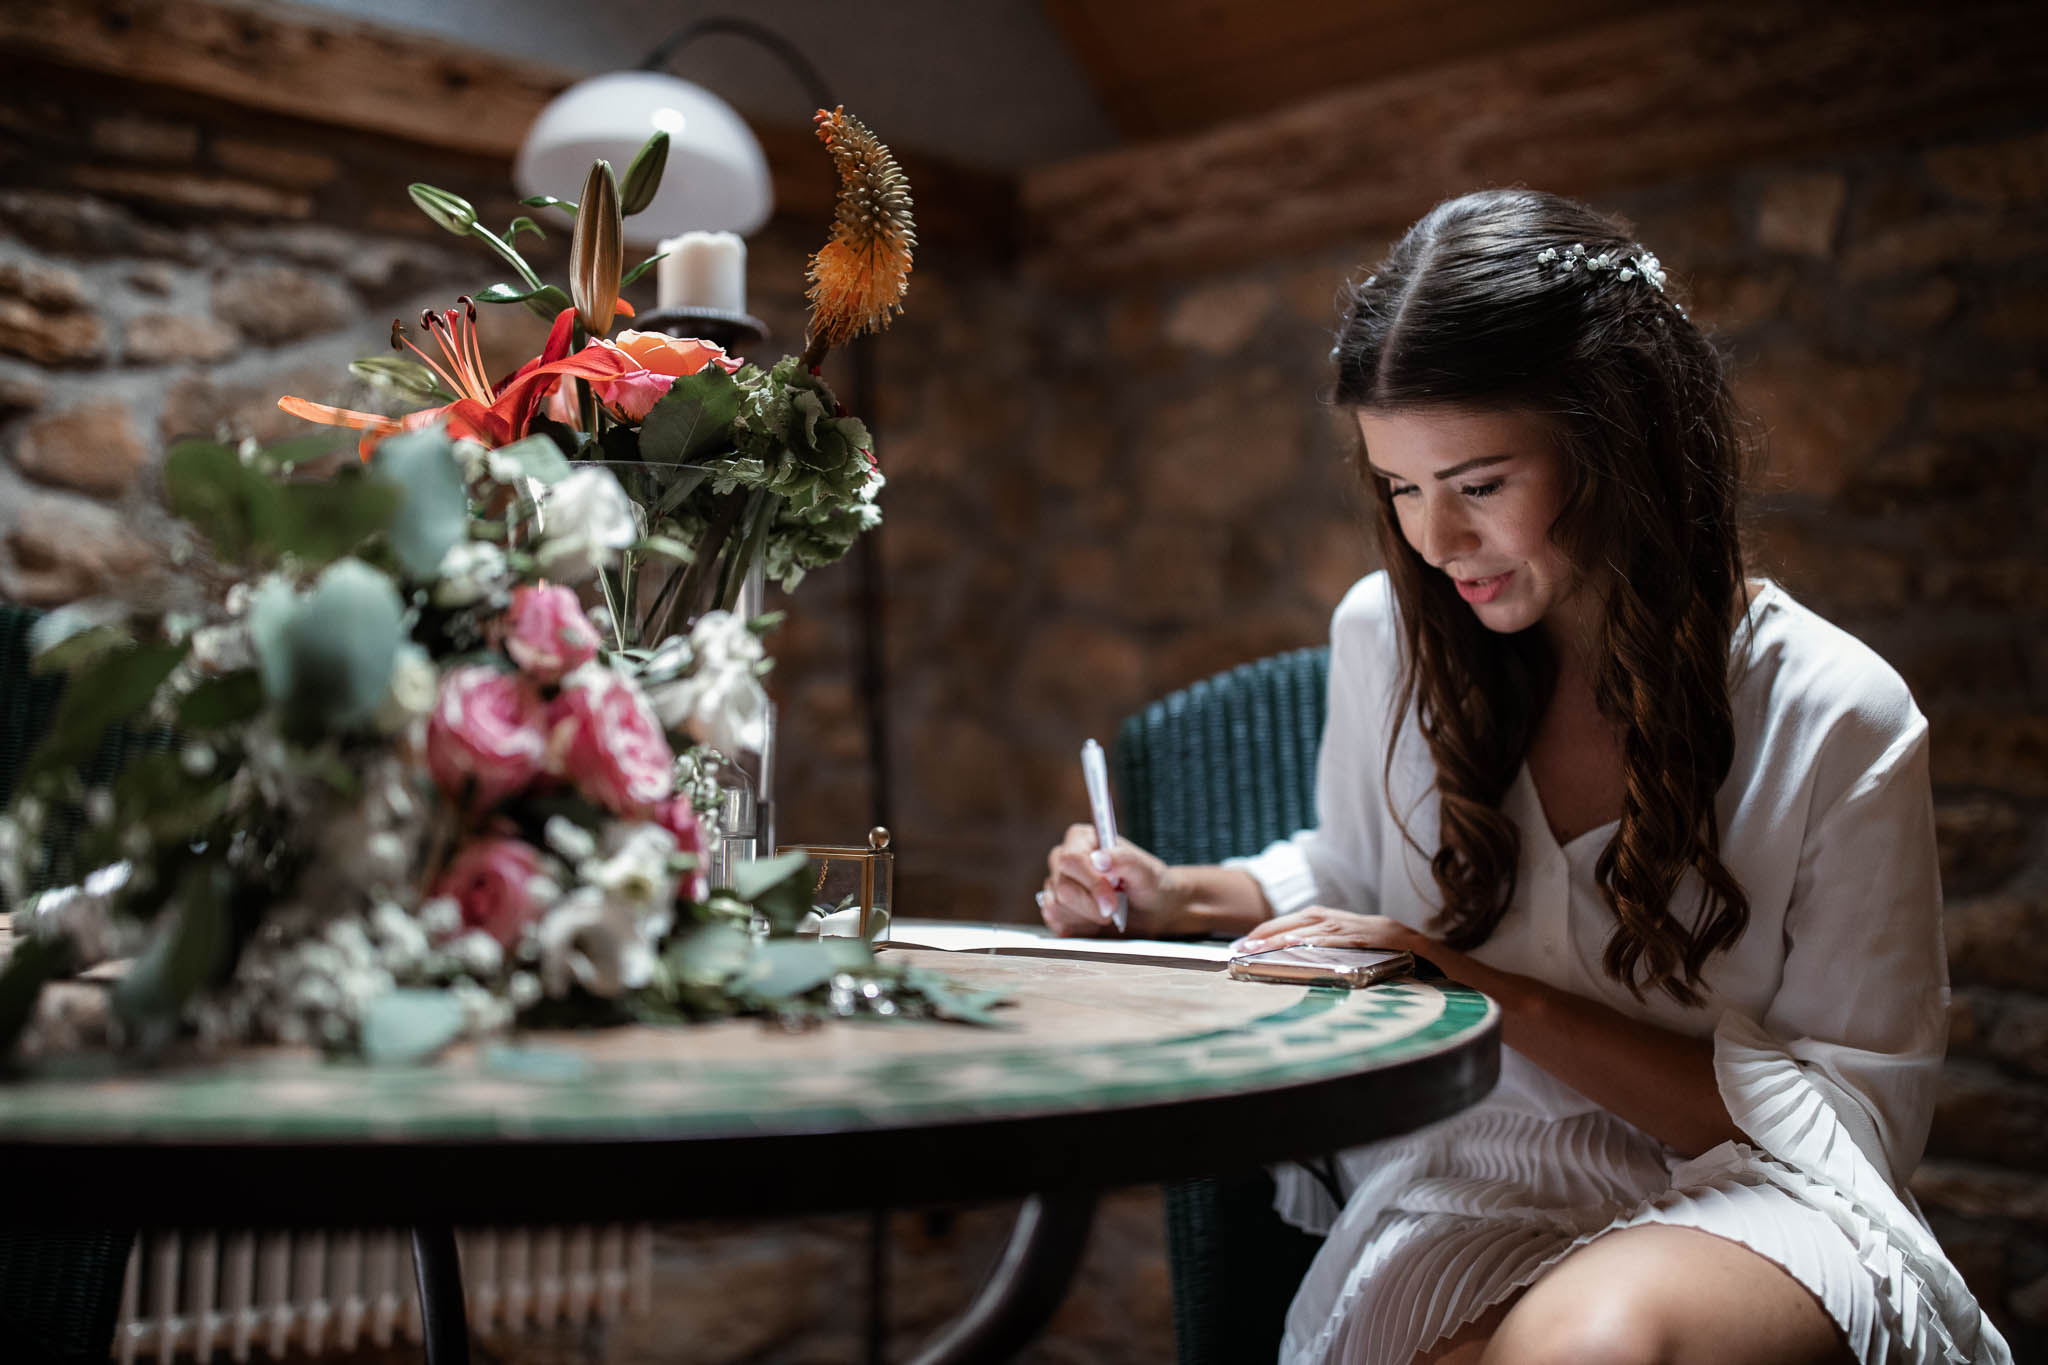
xmin=0 ymin=602 xmax=146 ymax=1365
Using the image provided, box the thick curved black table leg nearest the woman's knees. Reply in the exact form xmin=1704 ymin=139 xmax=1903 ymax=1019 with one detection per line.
xmin=911 ymin=1191 xmax=1096 ymax=1365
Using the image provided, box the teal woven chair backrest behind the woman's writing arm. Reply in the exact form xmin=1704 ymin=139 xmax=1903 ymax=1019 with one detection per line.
xmin=1116 ymin=647 xmax=1329 ymax=864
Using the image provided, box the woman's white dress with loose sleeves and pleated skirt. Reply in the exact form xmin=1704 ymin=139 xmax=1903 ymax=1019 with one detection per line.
xmin=1237 ymin=573 xmax=2011 ymax=1365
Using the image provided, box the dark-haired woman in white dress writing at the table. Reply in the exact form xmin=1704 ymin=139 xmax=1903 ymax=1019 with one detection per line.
xmin=1040 ymin=190 xmax=2009 ymax=1365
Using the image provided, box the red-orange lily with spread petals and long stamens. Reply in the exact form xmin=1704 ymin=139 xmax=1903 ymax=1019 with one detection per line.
xmin=276 ymin=297 xmax=641 ymax=460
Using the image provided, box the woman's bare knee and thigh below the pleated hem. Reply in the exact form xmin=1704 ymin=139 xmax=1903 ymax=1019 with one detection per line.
xmin=1479 ymin=1224 xmax=1849 ymax=1365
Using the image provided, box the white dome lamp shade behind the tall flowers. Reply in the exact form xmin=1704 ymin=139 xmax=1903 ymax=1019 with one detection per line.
xmin=512 ymin=72 xmax=774 ymax=244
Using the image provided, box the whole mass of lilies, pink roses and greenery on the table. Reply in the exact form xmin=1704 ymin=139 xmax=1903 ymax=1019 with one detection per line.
xmin=0 ymin=115 xmax=989 ymax=1058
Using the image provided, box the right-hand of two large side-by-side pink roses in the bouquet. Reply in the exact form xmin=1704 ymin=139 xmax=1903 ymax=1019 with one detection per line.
xmin=547 ymin=663 xmax=676 ymax=821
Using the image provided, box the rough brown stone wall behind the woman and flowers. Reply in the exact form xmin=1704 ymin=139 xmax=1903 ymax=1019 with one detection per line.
xmin=0 ymin=37 xmax=2048 ymax=1361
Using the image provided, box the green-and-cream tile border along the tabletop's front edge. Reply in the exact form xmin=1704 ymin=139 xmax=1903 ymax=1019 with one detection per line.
xmin=0 ymin=982 xmax=1495 ymax=1142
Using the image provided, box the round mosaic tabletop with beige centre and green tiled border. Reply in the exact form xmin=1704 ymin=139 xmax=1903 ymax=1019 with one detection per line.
xmin=0 ymin=950 xmax=1497 ymax=1144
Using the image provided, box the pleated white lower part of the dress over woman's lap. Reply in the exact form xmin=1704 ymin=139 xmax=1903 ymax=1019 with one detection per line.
xmin=1278 ymin=1015 xmax=2011 ymax=1365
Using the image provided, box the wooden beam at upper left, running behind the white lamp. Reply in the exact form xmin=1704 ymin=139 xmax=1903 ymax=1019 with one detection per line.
xmin=0 ymin=0 xmax=1018 ymax=254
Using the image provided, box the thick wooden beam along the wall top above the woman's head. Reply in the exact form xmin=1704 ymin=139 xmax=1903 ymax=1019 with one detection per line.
xmin=1024 ymin=0 xmax=2048 ymax=282
